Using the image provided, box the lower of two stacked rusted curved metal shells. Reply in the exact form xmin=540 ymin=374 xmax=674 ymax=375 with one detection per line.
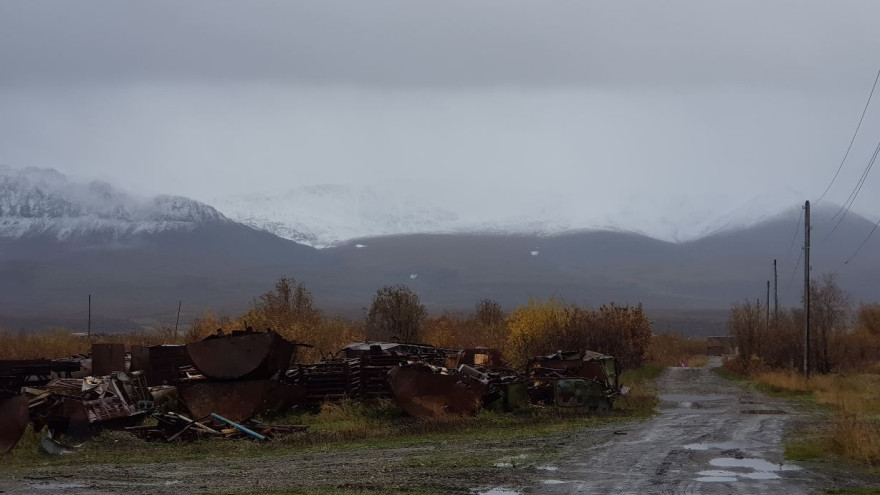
xmin=178 ymin=380 xmax=306 ymax=421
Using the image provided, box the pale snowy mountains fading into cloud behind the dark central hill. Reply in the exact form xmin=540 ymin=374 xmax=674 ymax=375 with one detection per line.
xmin=209 ymin=185 xmax=804 ymax=248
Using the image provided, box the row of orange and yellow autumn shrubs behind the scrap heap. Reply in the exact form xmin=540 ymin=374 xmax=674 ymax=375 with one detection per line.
xmin=0 ymin=277 xmax=705 ymax=369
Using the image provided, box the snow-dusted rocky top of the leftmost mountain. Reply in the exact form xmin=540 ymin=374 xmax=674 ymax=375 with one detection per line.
xmin=0 ymin=165 xmax=229 ymax=240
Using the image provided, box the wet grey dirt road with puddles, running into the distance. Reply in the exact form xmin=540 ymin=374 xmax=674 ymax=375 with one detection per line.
xmin=525 ymin=363 xmax=818 ymax=494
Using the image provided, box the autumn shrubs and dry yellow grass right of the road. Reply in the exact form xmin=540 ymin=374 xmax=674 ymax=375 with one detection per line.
xmin=725 ymin=275 xmax=880 ymax=467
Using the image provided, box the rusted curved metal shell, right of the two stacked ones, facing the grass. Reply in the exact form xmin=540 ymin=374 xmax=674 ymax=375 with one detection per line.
xmin=388 ymin=364 xmax=486 ymax=418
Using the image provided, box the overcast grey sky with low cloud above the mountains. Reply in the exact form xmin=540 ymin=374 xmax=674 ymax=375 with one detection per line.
xmin=0 ymin=0 xmax=880 ymax=227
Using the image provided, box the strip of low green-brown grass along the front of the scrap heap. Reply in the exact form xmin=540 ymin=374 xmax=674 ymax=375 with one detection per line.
xmin=0 ymin=401 xmax=645 ymax=472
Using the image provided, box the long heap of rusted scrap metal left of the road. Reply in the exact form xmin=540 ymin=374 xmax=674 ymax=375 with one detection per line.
xmin=0 ymin=328 xmax=626 ymax=454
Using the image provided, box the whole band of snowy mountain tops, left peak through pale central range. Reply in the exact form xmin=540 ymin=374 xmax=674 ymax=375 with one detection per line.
xmin=0 ymin=165 xmax=816 ymax=248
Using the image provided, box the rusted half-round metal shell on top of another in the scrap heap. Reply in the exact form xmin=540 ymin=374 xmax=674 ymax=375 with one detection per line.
xmin=186 ymin=331 xmax=296 ymax=380
